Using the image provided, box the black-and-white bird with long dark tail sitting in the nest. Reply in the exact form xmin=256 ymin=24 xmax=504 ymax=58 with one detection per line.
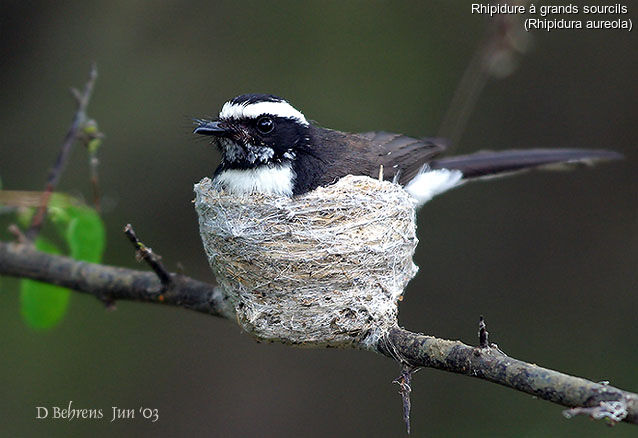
xmin=193 ymin=93 xmax=622 ymax=208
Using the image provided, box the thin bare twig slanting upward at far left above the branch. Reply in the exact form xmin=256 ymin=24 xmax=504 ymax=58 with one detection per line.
xmin=26 ymin=64 xmax=97 ymax=241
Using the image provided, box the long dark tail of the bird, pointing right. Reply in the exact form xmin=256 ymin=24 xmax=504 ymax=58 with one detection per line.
xmin=429 ymin=149 xmax=623 ymax=179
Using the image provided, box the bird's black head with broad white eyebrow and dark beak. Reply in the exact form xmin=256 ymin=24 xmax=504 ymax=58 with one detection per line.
xmin=193 ymin=94 xmax=310 ymax=169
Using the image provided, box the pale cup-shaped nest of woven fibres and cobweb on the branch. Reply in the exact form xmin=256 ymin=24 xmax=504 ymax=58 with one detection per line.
xmin=195 ymin=176 xmax=418 ymax=347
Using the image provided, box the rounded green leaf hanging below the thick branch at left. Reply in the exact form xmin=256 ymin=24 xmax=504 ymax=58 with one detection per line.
xmin=20 ymin=237 xmax=71 ymax=330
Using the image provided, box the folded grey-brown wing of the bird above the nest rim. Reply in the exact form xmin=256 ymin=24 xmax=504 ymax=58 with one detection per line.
xmin=353 ymin=131 xmax=445 ymax=184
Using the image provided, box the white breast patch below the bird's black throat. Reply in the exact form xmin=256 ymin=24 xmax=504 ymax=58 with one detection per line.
xmin=213 ymin=164 xmax=295 ymax=196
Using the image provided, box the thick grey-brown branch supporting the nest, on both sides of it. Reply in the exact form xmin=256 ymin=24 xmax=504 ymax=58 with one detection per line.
xmin=0 ymin=242 xmax=638 ymax=424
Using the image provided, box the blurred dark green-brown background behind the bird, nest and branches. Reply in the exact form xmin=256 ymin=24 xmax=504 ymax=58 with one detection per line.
xmin=0 ymin=0 xmax=638 ymax=437
